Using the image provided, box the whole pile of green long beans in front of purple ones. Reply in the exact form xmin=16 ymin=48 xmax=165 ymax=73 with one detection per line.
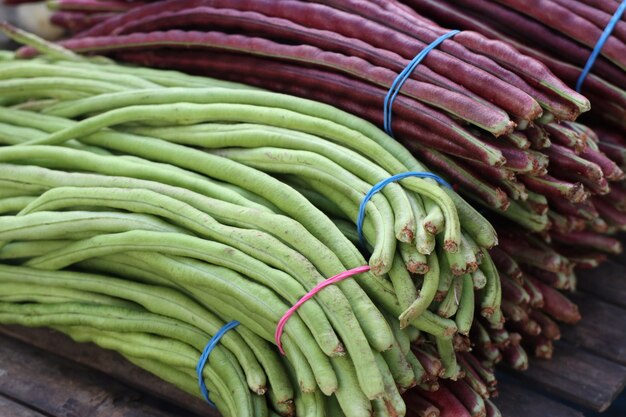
xmin=0 ymin=37 xmax=502 ymax=417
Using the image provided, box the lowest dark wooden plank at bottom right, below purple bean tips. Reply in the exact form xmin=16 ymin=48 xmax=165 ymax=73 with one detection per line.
xmin=494 ymin=377 xmax=583 ymax=417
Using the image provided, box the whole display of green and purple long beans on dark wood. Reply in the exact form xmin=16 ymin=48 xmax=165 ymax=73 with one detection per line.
xmin=0 ymin=0 xmax=626 ymax=416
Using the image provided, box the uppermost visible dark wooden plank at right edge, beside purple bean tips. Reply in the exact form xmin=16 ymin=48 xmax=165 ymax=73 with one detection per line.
xmin=577 ymin=261 xmax=626 ymax=307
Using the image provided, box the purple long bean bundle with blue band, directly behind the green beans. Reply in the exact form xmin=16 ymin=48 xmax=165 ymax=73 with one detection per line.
xmin=13 ymin=0 xmax=626 ymax=247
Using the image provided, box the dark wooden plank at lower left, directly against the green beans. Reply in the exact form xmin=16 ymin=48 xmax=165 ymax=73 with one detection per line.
xmin=0 ymin=326 xmax=219 ymax=417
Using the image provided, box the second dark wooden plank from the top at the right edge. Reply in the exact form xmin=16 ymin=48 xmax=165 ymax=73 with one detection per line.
xmin=561 ymin=293 xmax=626 ymax=365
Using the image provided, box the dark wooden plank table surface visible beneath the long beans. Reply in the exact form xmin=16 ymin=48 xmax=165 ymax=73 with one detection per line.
xmin=0 ymin=256 xmax=626 ymax=417
